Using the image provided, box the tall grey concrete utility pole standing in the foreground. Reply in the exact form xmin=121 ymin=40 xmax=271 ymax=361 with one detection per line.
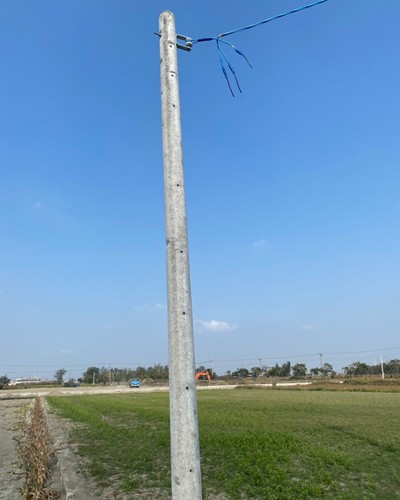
xmin=159 ymin=11 xmax=202 ymax=500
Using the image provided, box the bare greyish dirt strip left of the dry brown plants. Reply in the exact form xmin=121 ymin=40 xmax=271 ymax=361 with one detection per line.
xmin=0 ymin=399 xmax=31 ymax=500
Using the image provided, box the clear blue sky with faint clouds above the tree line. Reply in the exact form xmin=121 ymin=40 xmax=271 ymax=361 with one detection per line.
xmin=0 ymin=0 xmax=400 ymax=378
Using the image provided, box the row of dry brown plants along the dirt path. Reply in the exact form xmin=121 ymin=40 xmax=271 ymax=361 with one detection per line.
xmin=19 ymin=397 xmax=59 ymax=500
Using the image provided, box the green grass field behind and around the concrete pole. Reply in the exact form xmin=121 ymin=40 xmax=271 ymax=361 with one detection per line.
xmin=48 ymin=389 xmax=400 ymax=500
